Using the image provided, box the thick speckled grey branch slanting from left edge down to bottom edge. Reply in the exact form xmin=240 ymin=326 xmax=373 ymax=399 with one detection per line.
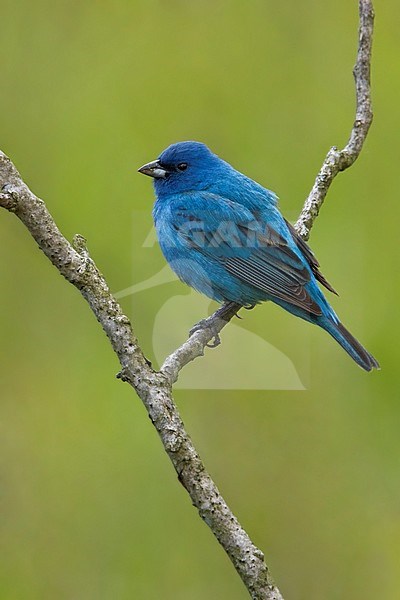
xmin=0 ymin=152 xmax=282 ymax=600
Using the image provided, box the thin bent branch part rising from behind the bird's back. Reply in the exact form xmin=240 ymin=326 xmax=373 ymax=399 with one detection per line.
xmin=295 ymin=0 xmax=374 ymax=240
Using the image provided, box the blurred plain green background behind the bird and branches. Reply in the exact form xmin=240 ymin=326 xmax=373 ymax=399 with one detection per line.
xmin=0 ymin=0 xmax=400 ymax=600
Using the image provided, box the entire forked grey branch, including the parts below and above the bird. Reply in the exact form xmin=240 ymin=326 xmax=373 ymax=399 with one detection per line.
xmin=0 ymin=0 xmax=374 ymax=600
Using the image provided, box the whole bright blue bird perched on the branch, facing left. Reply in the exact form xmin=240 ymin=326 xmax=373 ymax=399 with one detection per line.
xmin=139 ymin=141 xmax=379 ymax=371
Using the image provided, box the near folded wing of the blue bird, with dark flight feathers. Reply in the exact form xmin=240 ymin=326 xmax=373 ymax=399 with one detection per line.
xmin=173 ymin=192 xmax=322 ymax=315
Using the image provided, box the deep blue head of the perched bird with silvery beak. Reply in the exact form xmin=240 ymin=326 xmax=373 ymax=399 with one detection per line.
xmin=139 ymin=142 xmax=223 ymax=196
